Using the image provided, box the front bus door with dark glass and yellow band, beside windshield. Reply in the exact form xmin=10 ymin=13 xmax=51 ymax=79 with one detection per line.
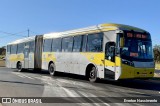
xmin=104 ymin=42 xmax=116 ymax=79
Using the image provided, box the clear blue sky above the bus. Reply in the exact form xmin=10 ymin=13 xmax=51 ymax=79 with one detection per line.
xmin=0 ymin=0 xmax=160 ymax=47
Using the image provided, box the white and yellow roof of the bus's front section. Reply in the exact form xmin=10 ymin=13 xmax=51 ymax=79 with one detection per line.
xmin=44 ymin=23 xmax=147 ymax=38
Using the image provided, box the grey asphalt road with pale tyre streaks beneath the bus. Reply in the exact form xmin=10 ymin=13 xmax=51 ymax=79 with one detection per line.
xmin=0 ymin=67 xmax=160 ymax=106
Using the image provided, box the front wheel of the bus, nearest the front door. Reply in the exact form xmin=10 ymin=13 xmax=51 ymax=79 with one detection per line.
xmin=89 ymin=67 xmax=97 ymax=82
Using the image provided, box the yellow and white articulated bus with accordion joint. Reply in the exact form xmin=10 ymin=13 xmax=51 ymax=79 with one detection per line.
xmin=6 ymin=24 xmax=155 ymax=82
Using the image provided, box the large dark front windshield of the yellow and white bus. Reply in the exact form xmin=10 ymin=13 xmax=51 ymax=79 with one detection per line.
xmin=121 ymin=33 xmax=153 ymax=61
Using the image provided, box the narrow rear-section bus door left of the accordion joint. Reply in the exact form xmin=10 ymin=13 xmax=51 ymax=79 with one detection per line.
xmin=24 ymin=43 xmax=29 ymax=68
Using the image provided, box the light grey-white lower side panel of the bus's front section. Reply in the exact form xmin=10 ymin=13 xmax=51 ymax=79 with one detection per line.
xmin=42 ymin=52 xmax=104 ymax=78
